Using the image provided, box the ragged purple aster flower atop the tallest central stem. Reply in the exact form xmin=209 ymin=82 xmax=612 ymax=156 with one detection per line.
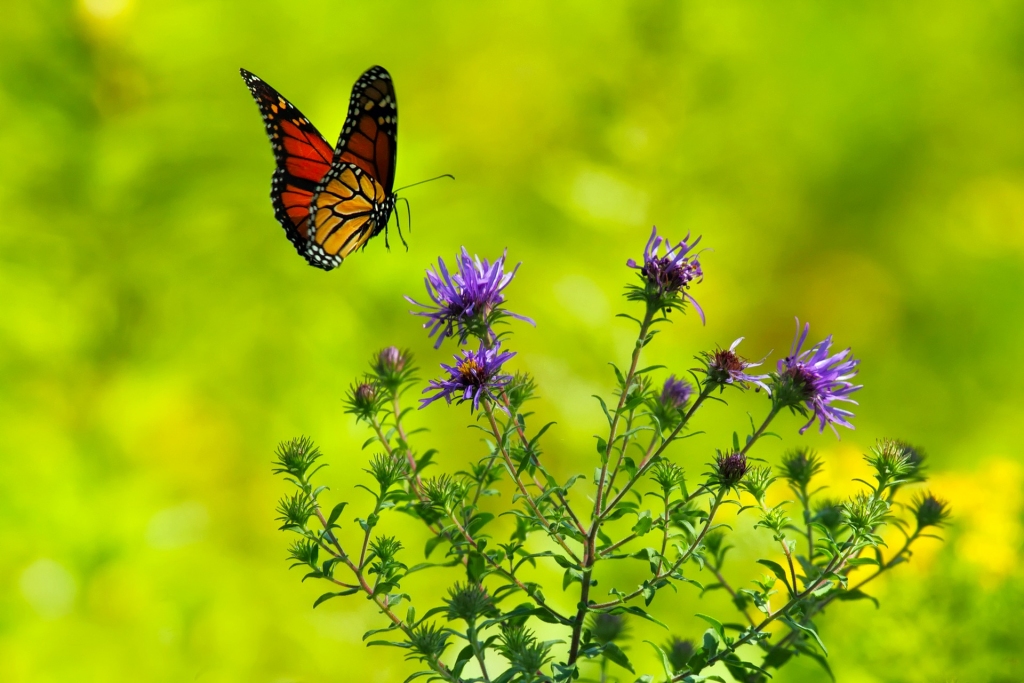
xmin=626 ymin=225 xmax=705 ymax=323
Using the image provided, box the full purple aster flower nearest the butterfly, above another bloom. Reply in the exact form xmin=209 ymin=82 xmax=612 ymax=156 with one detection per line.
xmin=406 ymin=247 xmax=534 ymax=348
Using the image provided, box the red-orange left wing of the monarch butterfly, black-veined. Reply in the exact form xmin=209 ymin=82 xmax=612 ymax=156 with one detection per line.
xmin=241 ymin=69 xmax=334 ymax=260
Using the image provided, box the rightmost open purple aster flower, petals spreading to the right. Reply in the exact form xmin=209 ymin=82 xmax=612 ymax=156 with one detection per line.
xmin=778 ymin=319 xmax=861 ymax=437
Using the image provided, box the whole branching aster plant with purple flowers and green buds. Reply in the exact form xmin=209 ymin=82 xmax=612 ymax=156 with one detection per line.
xmin=274 ymin=229 xmax=949 ymax=683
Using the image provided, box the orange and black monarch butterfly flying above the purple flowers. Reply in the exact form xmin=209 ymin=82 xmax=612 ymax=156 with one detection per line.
xmin=241 ymin=67 xmax=398 ymax=270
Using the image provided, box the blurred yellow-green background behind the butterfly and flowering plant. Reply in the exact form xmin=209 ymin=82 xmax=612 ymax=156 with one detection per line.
xmin=0 ymin=0 xmax=1024 ymax=683
